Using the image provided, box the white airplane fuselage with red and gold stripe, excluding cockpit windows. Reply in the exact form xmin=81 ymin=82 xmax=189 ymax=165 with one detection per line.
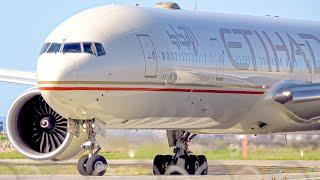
xmin=37 ymin=5 xmax=320 ymax=134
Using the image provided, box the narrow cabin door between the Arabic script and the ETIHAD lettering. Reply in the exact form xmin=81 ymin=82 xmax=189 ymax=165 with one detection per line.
xmin=210 ymin=38 xmax=224 ymax=81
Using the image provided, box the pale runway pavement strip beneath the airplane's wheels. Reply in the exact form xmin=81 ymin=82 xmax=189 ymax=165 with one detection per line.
xmin=0 ymin=160 xmax=320 ymax=180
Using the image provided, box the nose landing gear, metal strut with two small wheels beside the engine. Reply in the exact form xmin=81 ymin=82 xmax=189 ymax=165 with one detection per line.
xmin=77 ymin=120 xmax=108 ymax=176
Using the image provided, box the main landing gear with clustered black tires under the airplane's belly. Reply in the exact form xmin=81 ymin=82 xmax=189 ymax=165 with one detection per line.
xmin=153 ymin=130 xmax=208 ymax=175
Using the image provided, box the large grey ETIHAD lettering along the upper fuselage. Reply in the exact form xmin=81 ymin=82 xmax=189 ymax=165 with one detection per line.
xmin=219 ymin=28 xmax=320 ymax=73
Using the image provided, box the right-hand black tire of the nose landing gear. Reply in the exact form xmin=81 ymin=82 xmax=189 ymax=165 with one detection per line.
xmin=86 ymin=155 xmax=108 ymax=176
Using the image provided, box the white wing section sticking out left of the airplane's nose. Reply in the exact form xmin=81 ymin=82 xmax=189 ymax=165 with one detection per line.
xmin=0 ymin=69 xmax=37 ymax=85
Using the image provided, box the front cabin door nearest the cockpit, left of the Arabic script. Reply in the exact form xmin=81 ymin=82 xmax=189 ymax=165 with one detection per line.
xmin=137 ymin=35 xmax=158 ymax=78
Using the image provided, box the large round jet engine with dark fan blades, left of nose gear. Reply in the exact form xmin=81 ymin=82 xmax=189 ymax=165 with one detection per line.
xmin=7 ymin=88 xmax=88 ymax=160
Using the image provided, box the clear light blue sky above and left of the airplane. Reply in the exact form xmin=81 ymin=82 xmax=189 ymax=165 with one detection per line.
xmin=0 ymin=0 xmax=320 ymax=116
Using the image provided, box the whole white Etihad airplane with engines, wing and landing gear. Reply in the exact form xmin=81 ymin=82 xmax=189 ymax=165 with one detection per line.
xmin=1 ymin=3 xmax=320 ymax=175
